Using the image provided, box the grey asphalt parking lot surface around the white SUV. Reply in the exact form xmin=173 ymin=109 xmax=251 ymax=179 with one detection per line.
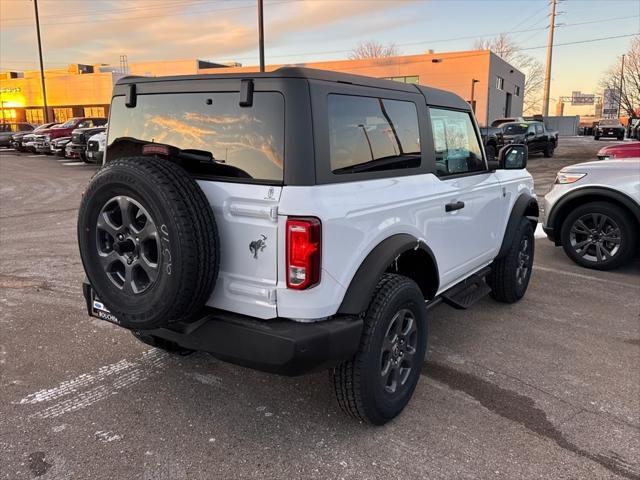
xmin=0 ymin=138 xmax=640 ymax=480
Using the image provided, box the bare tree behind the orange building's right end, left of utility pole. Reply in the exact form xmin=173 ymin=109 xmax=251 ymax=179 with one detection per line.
xmin=473 ymin=33 xmax=544 ymax=115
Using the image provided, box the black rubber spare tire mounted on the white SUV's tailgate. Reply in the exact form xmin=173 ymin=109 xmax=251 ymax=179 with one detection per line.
xmin=78 ymin=157 xmax=219 ymax=330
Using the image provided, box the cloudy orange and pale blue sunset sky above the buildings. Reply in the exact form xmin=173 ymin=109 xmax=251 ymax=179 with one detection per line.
xmin=0 ymin=0 xmax=640 ymax=102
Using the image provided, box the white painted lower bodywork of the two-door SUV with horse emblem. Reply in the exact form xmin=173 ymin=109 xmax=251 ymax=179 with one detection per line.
xmin=198 ymin=170 xmax=534 ymax=321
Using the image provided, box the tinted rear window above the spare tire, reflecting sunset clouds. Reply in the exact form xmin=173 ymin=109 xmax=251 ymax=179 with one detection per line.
xmin=108 ymin=92 xmax=284 ymax=182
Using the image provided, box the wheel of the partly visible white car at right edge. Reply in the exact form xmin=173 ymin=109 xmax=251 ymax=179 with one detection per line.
xmin=560 ymin=202 xmax=637 ymax=270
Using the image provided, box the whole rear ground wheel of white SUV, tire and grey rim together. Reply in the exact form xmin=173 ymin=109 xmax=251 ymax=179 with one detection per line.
xmin=331 ymin=274 xmax=427 ymax=425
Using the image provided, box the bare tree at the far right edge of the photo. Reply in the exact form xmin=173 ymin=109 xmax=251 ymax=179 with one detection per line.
xmin=600 ymin=37 xmax=640 ymax=117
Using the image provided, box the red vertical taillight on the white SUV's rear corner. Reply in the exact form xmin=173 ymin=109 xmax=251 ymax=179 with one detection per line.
xmin=286 ymin=217 xmax=322 ymax=290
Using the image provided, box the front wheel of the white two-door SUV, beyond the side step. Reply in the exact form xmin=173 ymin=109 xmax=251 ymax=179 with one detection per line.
xmin=487 ymin=217 xmax=535 ymax=303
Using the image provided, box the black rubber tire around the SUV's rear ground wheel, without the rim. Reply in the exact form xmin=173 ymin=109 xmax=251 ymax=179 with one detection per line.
xmin=330 ymin=274 xmax=427 ymax=425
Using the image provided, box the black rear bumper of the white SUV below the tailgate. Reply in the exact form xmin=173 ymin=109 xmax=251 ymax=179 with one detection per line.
xmin=83 ymin=282 xmax=363 ymax=376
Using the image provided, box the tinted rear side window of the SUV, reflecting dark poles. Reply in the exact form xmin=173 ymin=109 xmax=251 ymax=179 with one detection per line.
xmin=328 ymin=94 xmax=420 ymax=174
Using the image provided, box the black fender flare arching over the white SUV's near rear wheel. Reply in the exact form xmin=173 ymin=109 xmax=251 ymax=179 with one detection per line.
xmin=338 ymin=233 xmax=440 ymax=315
